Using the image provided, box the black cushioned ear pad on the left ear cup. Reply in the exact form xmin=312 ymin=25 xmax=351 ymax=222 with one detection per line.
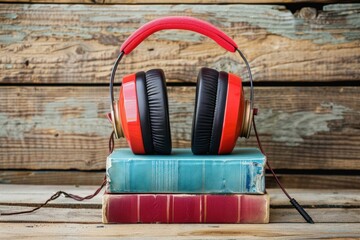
xmin=136 ymin=69 xmax=171 ymax=154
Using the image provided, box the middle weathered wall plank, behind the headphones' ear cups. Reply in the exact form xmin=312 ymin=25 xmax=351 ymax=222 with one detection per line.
xmin=0 ymin=87 xmax=360 ymax=170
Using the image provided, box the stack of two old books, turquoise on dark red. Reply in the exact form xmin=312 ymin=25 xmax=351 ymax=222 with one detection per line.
xmin=103 ymin=148 xmax=270 ymax=223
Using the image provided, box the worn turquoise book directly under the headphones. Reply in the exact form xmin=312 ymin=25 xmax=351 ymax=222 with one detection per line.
xmin=106 ymin=148 xmax=266 ymax=194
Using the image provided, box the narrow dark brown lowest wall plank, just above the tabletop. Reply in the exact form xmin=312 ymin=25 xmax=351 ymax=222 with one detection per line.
xmin=0 ymin=170 xmax=360 ymax=189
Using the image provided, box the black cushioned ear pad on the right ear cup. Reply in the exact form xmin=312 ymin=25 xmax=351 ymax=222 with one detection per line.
xmin=191 ymin=68 xmax=228 ymax=154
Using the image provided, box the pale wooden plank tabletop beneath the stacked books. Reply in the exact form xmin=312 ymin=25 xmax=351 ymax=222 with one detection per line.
xmin=0 ymin=184 xmax=360 ymax=239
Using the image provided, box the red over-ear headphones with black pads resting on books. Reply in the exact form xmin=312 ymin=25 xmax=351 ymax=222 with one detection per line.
xmin=108 ymin=17 xmax=254 ymax=154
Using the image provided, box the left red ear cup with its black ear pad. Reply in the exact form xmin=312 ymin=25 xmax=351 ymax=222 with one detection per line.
xmin=119 ymin=69 xmax=171 ymax=154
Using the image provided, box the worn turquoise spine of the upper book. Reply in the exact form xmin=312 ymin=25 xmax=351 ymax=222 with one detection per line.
xmin=107 ymin=158 xmax=265 ymax=194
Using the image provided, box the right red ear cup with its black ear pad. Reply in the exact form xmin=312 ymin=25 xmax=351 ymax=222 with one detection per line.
xmin=191 ymin=68 xmax=244 ymax=154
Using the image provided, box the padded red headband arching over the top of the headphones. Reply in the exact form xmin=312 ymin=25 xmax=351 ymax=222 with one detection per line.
xmin=120 ymin=17 xmax=238 ymax=55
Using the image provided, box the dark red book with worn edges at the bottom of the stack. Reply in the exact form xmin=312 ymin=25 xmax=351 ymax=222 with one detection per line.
xmin=103 ymin=194 xmax=270 ymax=223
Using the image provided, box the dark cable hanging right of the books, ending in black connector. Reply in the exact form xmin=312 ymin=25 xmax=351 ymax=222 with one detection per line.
xmin=252 ymin=108 xmax=314 ymax=223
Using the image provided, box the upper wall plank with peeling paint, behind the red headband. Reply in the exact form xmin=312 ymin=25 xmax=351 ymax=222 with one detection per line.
xmin=0 ymin=4 xmax=360 ymax=84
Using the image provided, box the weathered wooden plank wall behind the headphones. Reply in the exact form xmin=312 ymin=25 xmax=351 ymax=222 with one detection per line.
xmin=0 ymin=0 xmax=360 ymax=188
